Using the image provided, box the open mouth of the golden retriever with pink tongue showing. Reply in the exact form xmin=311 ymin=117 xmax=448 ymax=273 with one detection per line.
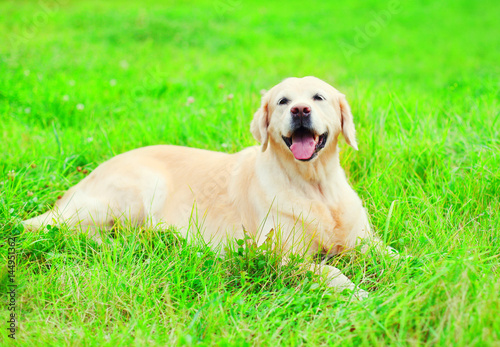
xmin=281 ymin=127 xmax=328 ymax=161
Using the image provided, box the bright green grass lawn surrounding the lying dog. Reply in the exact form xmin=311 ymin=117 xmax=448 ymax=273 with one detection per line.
xmin=0 ymin=0 xmax=500 ymax=346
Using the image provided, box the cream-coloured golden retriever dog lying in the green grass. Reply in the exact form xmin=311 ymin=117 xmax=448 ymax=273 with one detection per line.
xmin=24 ymin=77 xmax=392 ymax=297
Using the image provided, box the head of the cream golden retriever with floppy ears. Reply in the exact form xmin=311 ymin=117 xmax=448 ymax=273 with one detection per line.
xmin=250 ymin=77 xmax=358 ymax=161
